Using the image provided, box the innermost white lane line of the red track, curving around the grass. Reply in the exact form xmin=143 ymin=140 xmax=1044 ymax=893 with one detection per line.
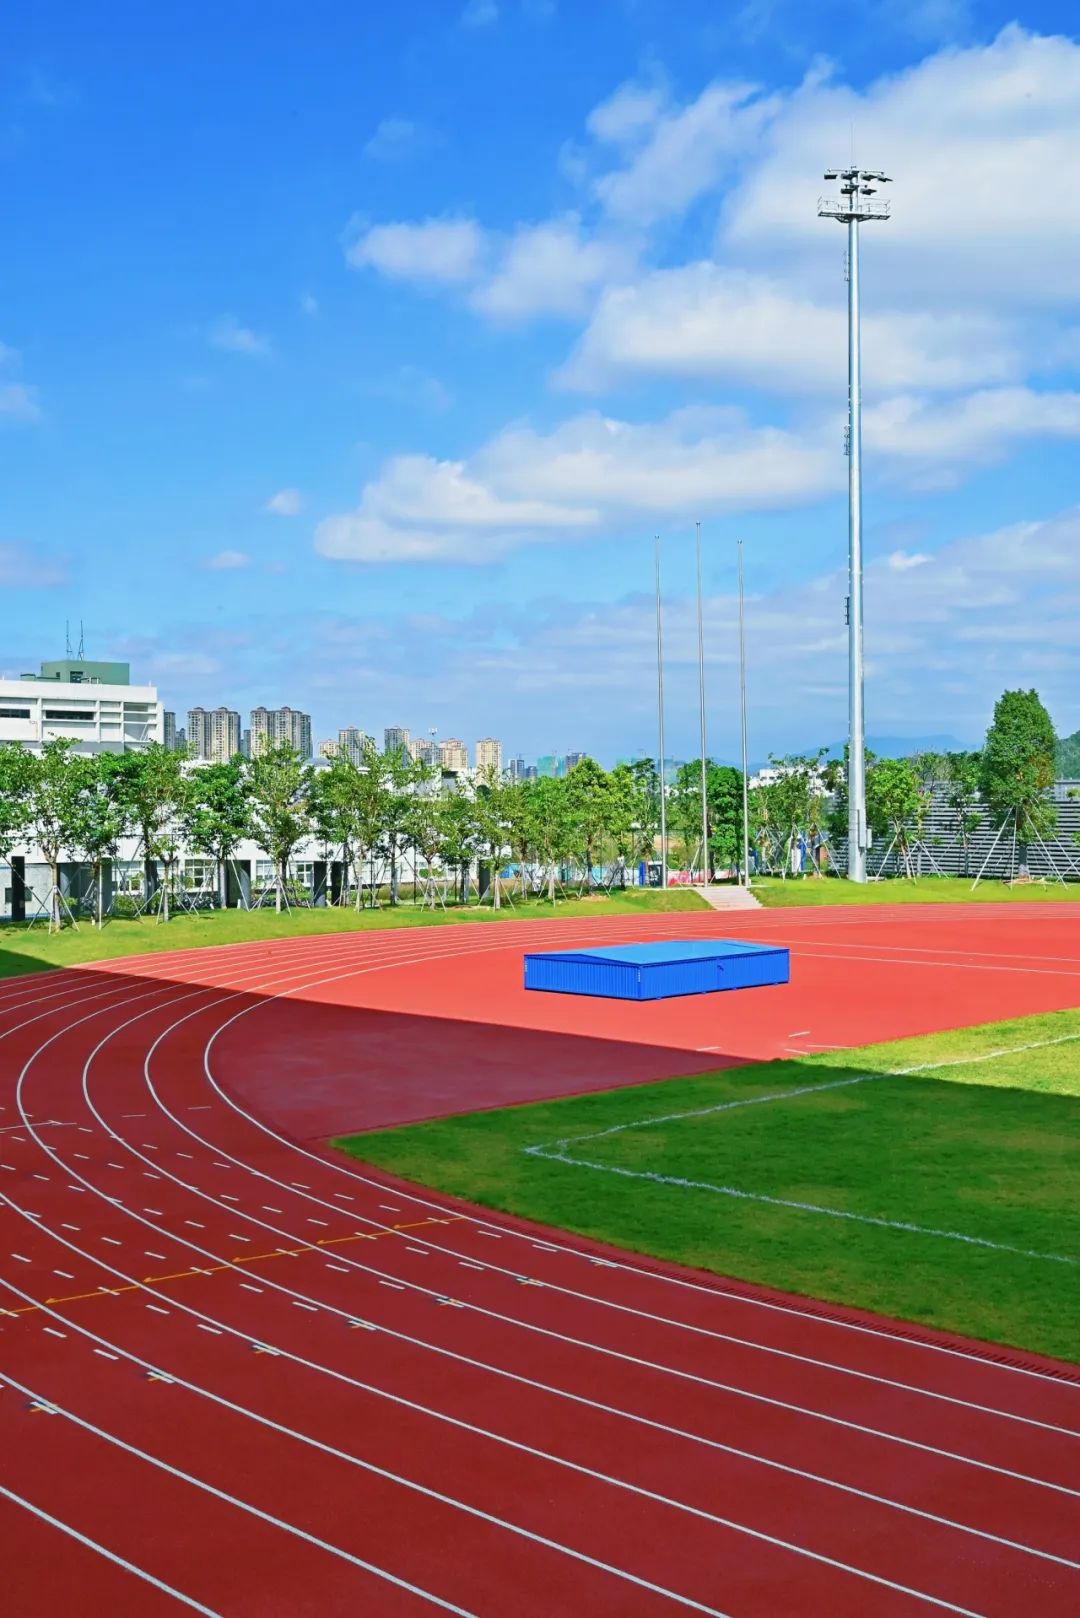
xmin=175 ymin=906 xmax=1080 ymax=1388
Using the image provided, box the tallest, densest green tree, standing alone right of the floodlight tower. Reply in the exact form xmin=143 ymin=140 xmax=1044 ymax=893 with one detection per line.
xmin=978 ymin=691 xmax=1057 ymax=875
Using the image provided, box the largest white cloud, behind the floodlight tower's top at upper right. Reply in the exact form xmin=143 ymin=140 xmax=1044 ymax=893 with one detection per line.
xmin=721 ymin=26 xmax=1080 ymax=304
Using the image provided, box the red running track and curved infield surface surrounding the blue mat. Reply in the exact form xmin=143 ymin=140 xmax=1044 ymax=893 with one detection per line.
xmin=0 ymin=904 xmax=1080 ymax=1618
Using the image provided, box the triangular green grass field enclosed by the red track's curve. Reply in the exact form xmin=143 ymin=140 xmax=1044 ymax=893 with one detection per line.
xmin=337 ymin=1011 xmax=1080 ymax=1359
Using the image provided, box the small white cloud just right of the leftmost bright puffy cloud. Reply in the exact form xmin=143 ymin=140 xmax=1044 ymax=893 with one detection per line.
xmin=470 ymin=214 xmax=635 ymax=320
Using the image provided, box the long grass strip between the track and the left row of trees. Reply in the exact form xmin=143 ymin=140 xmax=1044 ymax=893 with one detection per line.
xmin=0 ymin=888 xmax=704 ymax=977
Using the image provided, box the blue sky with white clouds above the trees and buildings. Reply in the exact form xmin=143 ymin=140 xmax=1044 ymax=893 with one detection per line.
xmin=0 ymin=0 xmax=1080 ymax=759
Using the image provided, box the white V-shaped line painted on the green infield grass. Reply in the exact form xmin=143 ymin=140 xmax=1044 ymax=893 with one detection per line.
xmin=521 ymin=1032 xmax=1080 ymax=1265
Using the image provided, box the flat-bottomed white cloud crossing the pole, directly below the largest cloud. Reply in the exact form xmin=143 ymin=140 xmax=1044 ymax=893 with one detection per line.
xmin=562 ymin=262 xmax=1022 ymax=393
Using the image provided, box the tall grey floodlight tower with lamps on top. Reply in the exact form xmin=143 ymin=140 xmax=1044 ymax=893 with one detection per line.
xmin=818 ymin=168 xmax=889 ymax=882
